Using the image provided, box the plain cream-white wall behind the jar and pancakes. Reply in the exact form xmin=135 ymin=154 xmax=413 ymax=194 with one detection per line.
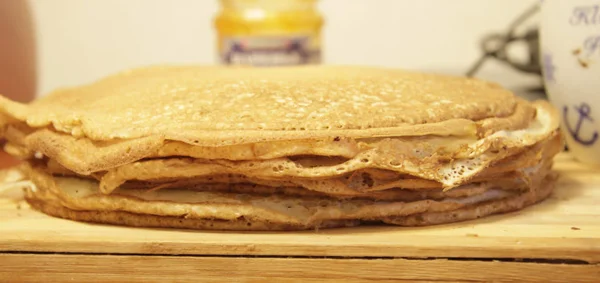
xmin=30 ymin=0 xmax=535 ymax=95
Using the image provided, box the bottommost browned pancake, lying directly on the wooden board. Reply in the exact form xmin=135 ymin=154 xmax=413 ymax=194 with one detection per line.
xmin=27 ymin=178 xmax=554 ymax=231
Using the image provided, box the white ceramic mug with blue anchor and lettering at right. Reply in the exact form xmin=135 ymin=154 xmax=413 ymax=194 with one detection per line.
xmin=540 ymin=0 xmax=600 ymax=165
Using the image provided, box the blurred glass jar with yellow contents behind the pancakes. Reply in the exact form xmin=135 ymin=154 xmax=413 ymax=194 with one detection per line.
xmin=215 ymin=0 xmax=323 ymax=66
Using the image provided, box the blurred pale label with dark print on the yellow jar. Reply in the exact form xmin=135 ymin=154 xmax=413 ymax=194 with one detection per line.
xmin=221 ymin=36 xmax=321 ymax=66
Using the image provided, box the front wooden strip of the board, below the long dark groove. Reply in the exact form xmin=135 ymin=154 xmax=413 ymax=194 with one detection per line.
xmin=0 ymin=254 xmax=600 ymax=283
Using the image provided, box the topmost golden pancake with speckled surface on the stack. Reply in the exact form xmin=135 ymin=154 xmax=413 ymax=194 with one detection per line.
xmin=0 ymin=66 xmax=519 ymax=146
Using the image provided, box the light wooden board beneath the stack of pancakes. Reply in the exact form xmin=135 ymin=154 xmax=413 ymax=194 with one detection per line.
xmin=0 ymin=154 xmax=600 ymax=282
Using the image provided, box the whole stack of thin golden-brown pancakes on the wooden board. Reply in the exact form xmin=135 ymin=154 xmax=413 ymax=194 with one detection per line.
xmin=0 ymin=66 xmax=562 ymax=230
